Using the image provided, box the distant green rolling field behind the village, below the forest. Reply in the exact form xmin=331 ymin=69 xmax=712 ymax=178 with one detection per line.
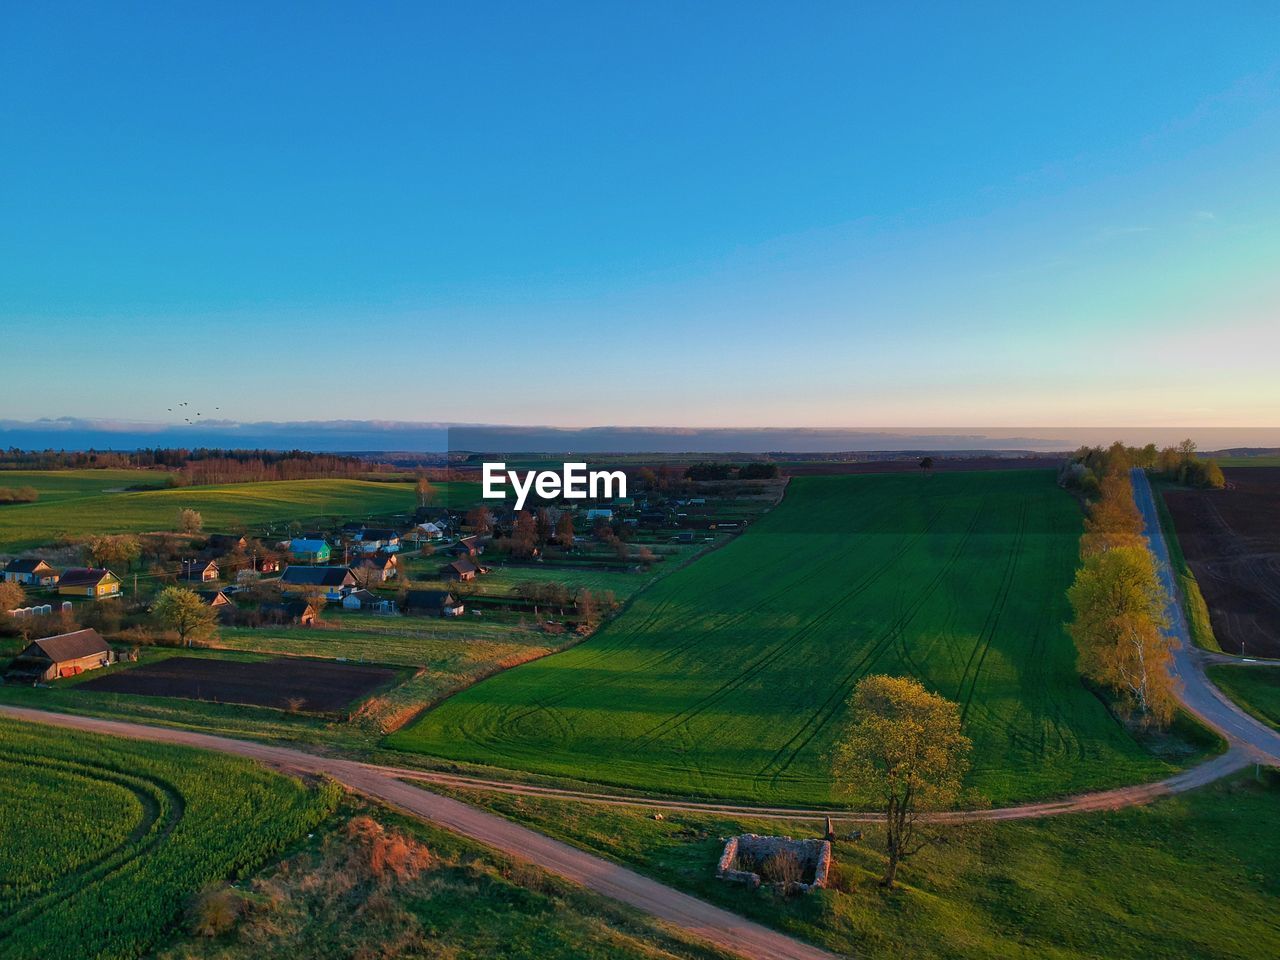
xmin=0 ymin=470 xmax=479 ymax=552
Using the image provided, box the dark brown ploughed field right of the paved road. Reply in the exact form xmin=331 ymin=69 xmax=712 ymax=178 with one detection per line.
xmin=1164 ymin=467 xmax=1280 ymax=657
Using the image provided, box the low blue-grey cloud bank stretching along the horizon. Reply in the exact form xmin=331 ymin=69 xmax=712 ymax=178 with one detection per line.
xmin=0 ymin=417 xmax=1280 ymax=453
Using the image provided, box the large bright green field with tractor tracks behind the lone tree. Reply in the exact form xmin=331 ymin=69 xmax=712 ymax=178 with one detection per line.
xmin=388 ymin=471 xmax=1170 ymax=803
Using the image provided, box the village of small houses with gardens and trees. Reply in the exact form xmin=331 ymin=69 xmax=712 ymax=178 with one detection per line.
xmin=0 ymin=468 xmax=781 ymax=722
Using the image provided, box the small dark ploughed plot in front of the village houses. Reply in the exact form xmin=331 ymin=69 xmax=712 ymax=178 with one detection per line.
xmin=79 ymin=657 xmax=397 ymax=713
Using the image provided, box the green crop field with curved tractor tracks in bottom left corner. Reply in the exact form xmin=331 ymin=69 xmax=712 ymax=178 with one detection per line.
xmin=0 ymin=719 xmax=338 ymax=960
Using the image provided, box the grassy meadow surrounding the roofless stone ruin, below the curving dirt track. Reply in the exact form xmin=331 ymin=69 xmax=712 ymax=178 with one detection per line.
xmin=435 ymin=771 xmax=1280 ymax=960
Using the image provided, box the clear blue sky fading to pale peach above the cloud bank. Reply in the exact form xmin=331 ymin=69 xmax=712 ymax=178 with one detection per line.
xmin=0 ymin=0 xmax=1280 ymax=426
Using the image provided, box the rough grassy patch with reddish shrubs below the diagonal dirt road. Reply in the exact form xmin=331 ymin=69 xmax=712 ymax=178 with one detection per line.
xmin=157 ymin=797 xmax=723 ymax=960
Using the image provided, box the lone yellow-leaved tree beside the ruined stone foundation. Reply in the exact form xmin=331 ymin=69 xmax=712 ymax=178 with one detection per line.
xmin=831 ymin=676 xmax=973 ymax=887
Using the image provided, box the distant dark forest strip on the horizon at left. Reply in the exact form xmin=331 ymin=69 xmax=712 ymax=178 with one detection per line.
xmin=0 ymin=447 xmax=390 ymax=486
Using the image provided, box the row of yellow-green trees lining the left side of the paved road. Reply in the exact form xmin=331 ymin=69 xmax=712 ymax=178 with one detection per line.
xmin=1068 ymin=444 xmax=1178 ymax=727
